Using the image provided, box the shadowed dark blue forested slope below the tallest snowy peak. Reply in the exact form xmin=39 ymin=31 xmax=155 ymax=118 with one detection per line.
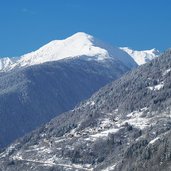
xmin=0 ymin=56 xmax=130 ymax=147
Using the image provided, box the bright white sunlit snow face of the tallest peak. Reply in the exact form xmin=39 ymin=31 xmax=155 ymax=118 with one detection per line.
xmin=19 ymin=32 xmax=109 ymax=66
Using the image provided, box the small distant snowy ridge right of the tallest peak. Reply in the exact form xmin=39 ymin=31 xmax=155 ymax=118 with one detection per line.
xmin=120 ymin=47 xmax=160 ymax=65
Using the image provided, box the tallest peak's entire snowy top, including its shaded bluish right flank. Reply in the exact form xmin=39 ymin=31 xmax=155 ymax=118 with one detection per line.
xmin=0 ymin=32 xmax=136 ymax=71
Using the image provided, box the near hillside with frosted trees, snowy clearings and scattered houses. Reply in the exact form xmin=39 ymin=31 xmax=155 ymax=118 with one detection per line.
xmin=0 ymin=50 xmax=171 ymax=171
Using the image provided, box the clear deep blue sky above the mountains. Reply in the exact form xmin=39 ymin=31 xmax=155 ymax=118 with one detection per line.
xmin=0 ymin=0 xmax=171 ymax=56
